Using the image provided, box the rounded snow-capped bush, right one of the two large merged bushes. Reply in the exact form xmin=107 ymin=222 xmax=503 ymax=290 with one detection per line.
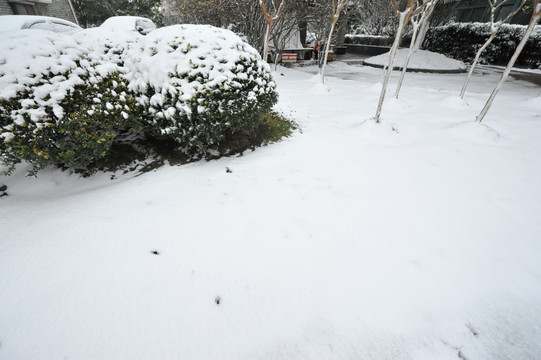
xmin=125 ymin=25 xmax=277 ymax=152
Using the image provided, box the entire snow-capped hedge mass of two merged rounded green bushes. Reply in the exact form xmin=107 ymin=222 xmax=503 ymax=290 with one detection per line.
xmin=0 ymin=26 xmax=277 ymax=174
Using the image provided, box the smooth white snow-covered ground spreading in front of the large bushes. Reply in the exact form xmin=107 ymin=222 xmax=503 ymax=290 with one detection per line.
xmin=0 ymin=57 xmax=541 ymax=360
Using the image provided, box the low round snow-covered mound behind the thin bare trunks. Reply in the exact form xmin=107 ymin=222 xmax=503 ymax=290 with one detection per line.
xmin=364 ymin=49 xmax=466 ymax=72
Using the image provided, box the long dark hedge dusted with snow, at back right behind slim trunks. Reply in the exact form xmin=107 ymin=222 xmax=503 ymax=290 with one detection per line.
xmin=425 ymin=23 xmax=541 ymax=68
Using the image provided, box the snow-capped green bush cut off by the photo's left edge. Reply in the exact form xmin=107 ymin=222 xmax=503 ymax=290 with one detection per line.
xmin=0 ymin=30 xmax=137 ymax=172
